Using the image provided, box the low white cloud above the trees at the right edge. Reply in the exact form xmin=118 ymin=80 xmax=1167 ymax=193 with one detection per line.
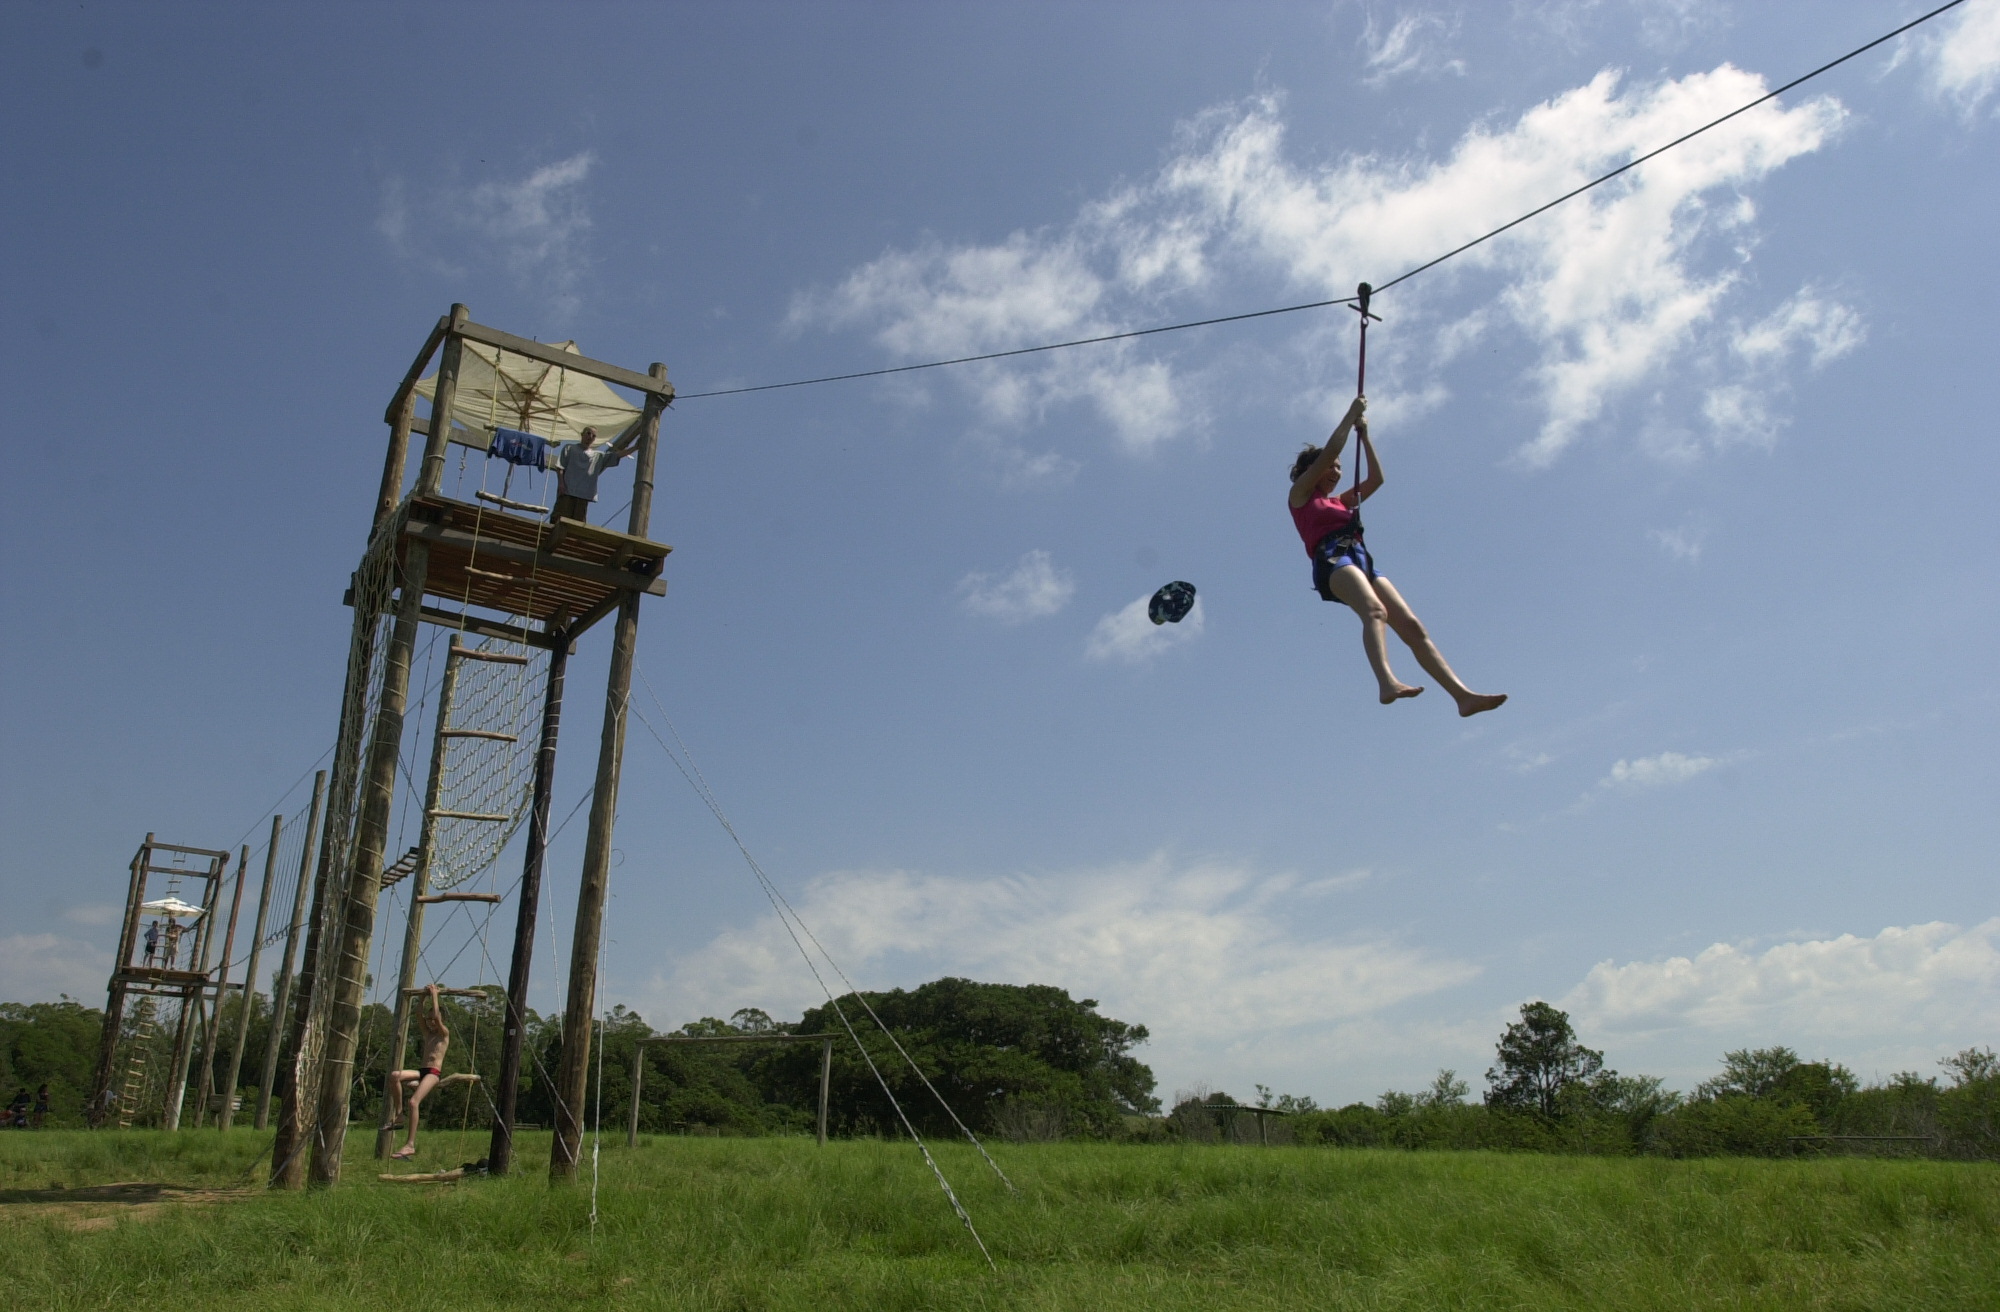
xmin=1562 ymin=918 xmax=2000 ymax=1074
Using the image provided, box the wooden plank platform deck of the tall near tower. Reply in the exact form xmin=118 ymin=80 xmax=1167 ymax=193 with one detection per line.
xmin=398 ymin=496 xmax=674 ymax=632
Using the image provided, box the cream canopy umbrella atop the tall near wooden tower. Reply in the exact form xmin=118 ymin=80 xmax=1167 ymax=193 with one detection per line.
xmin=416 ymin=342 xmax=640 ymax=450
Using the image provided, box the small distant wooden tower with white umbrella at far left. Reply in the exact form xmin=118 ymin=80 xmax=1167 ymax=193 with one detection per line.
xmin=88 ymin=834 xmax=242 ymax=1130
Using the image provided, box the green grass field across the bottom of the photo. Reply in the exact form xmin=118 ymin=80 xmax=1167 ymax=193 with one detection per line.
xmin=0 ymin=1132 xmax=2000 ymax=1312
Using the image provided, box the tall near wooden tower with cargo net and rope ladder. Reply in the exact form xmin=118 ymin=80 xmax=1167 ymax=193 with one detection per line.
xmin=272 ymin=306 xmax=674 ymax=1186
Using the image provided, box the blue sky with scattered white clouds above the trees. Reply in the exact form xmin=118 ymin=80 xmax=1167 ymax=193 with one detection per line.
xmin=0 ymin=0 xmax=2000 ymax=1102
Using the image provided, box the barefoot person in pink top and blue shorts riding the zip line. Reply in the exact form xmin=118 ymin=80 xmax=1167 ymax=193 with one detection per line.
xmin=1290 ymin=396 xmax=1506 ymax=716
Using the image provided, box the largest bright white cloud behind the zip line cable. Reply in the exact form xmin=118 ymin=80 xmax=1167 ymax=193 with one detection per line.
xmin=792 ymin=65 xmax=1860 ymax=464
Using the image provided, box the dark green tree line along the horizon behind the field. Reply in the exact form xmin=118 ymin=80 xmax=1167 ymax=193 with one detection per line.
xmin=0 ymin=978 xmax=2000 ymax=1158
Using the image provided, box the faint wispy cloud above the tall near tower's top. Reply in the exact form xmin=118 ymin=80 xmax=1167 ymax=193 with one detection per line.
xmin=376 ymin=150 xmax=596 ymax=318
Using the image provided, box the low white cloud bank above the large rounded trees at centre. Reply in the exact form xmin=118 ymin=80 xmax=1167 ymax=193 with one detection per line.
xmin=632 ymin=856 xmax=1476 ymax=1074
